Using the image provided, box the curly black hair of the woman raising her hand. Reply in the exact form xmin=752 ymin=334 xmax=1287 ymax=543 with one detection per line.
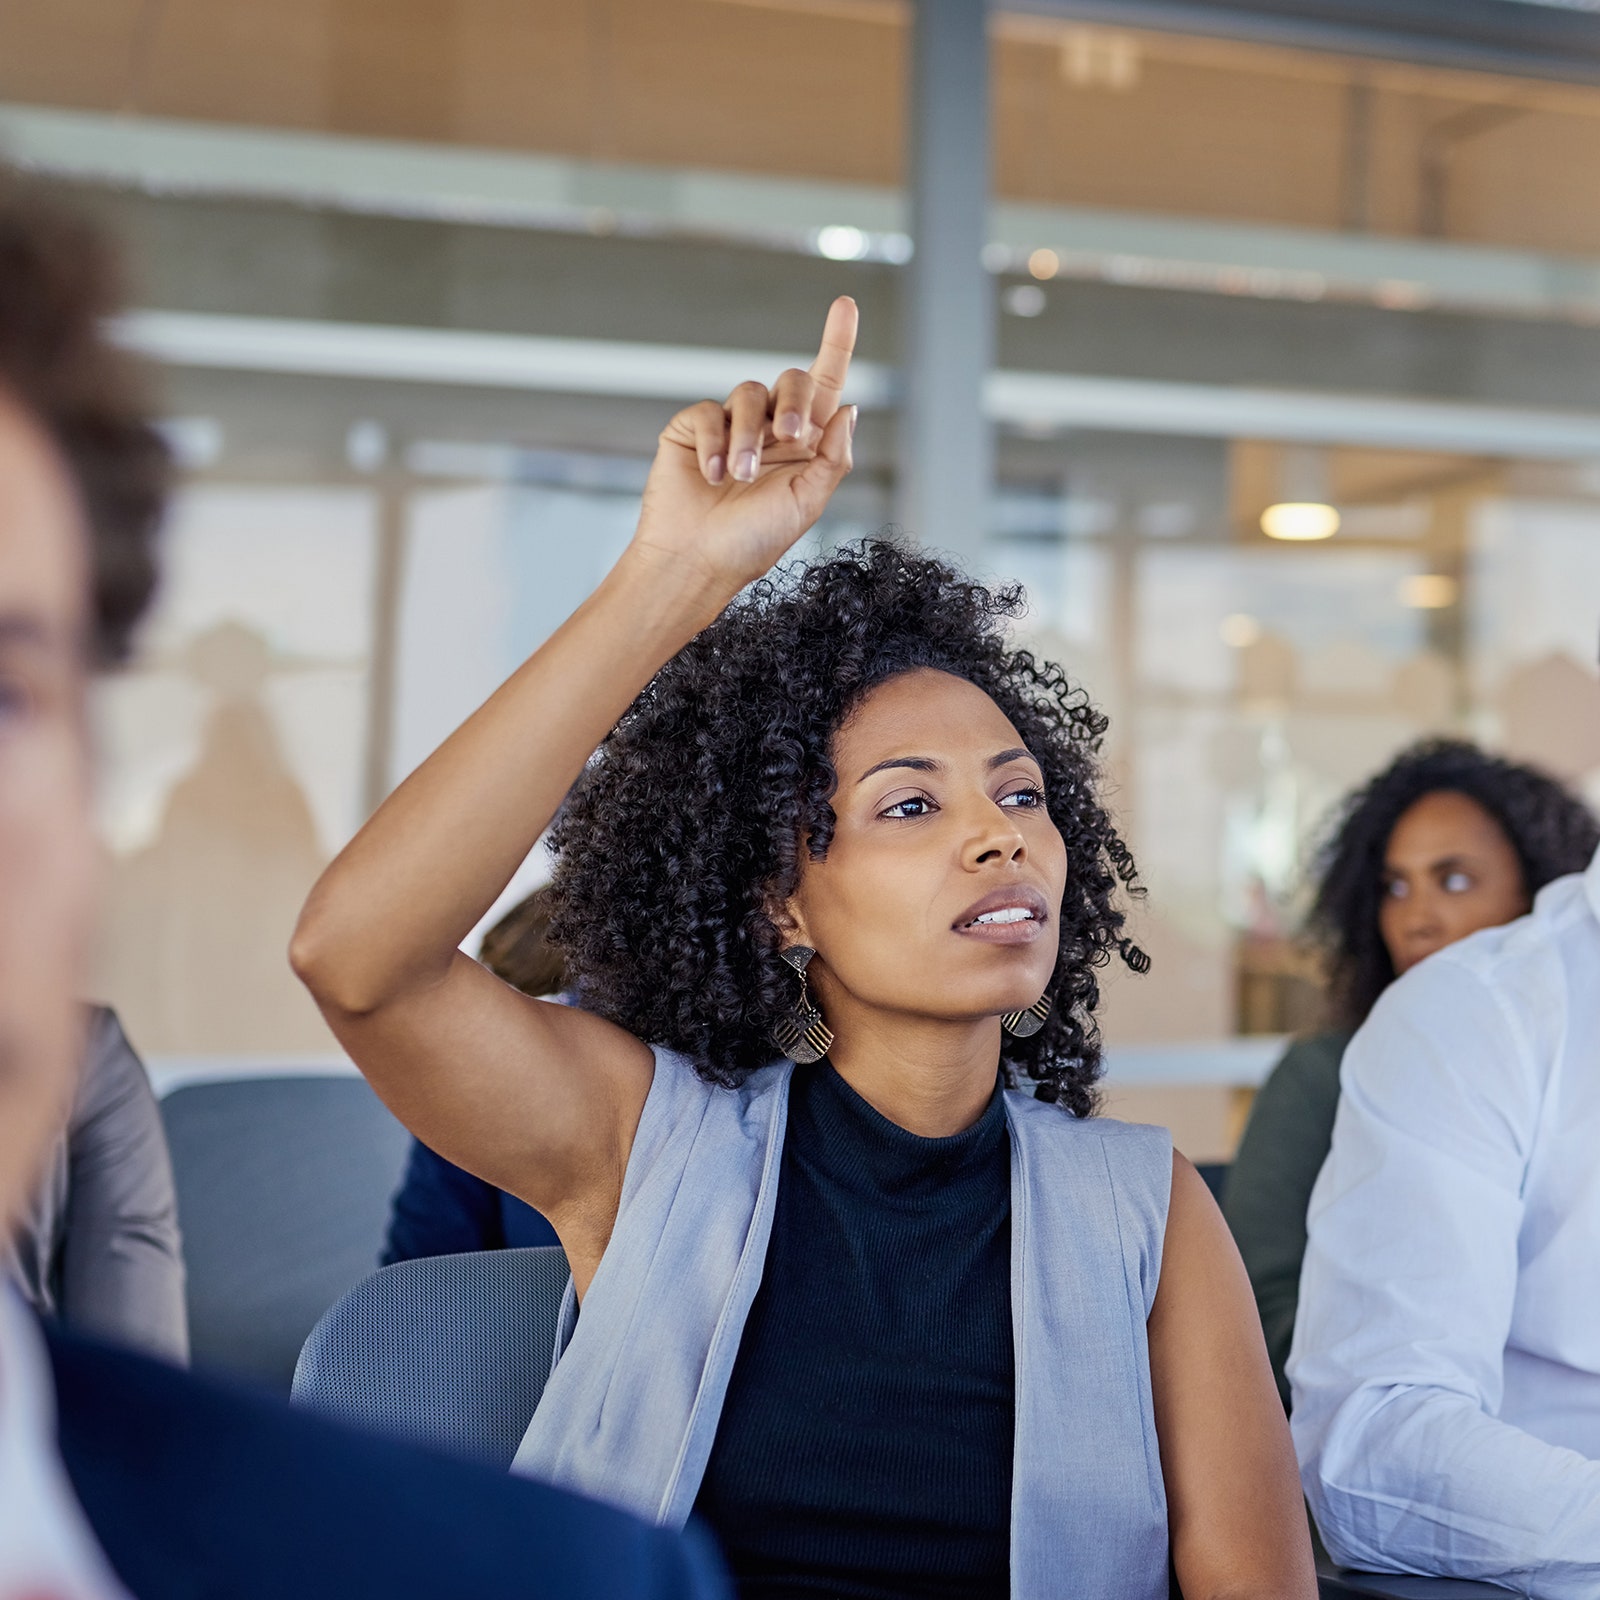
xmin=550 ymin=539 xmax=1149 ymax=1117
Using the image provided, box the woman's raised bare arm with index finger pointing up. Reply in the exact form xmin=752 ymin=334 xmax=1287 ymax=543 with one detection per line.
xmin=291 ymin=301 xmax=856 ymax=1282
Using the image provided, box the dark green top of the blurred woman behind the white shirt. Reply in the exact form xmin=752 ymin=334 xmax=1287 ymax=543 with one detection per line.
xmin=1222 ymin=1032 xmax=1350 ymax=1406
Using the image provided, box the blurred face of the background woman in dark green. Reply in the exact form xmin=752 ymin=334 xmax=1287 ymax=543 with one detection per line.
xmin=1378 ymin=789 xmax=1530 ymax=974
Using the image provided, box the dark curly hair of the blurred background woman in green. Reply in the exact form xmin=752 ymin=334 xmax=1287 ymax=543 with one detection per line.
xmin=1307 ymin=739 xmax=1600 ymax=1029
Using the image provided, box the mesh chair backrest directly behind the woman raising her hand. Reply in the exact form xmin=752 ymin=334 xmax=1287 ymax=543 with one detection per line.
xmin=294 ymin=1245 xmax=568 ymax=1467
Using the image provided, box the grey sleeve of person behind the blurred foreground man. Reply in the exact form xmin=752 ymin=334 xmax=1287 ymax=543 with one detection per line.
xmin=58 ymin=1010 xmax=189 ymax=1362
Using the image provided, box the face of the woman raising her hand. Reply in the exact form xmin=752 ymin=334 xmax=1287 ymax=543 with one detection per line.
xmin=789 ymin=669 xmax=1067 ymax=1026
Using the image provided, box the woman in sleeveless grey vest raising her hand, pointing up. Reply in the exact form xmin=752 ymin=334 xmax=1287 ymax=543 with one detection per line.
xmin=293 ymin=301 xmax=1315 ymax=1600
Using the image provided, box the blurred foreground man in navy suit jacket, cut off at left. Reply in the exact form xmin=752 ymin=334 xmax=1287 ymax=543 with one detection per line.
xmin=0 ymin=176 xmax=725 ymax=1600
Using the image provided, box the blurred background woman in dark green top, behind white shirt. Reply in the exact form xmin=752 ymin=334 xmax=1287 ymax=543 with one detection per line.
xmin=1222 ymin=739 xmax=1600 ymax=1406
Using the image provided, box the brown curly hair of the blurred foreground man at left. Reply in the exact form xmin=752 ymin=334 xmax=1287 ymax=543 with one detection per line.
xmin=0 ymin=170 xmax=171 ymax=666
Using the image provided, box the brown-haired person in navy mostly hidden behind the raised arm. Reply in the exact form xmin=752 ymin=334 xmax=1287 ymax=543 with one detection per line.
xmin=379 ymin=886 xmax=566 ymax=1267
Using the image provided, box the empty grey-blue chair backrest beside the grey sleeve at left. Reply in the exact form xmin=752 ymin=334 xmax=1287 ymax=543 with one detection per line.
xmin=162 ymin=1077 xmax=410 ymax=1394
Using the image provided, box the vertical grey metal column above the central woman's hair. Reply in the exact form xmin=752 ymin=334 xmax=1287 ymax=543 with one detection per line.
xmin=896 ymin=0 xmax=995 ymax=571
